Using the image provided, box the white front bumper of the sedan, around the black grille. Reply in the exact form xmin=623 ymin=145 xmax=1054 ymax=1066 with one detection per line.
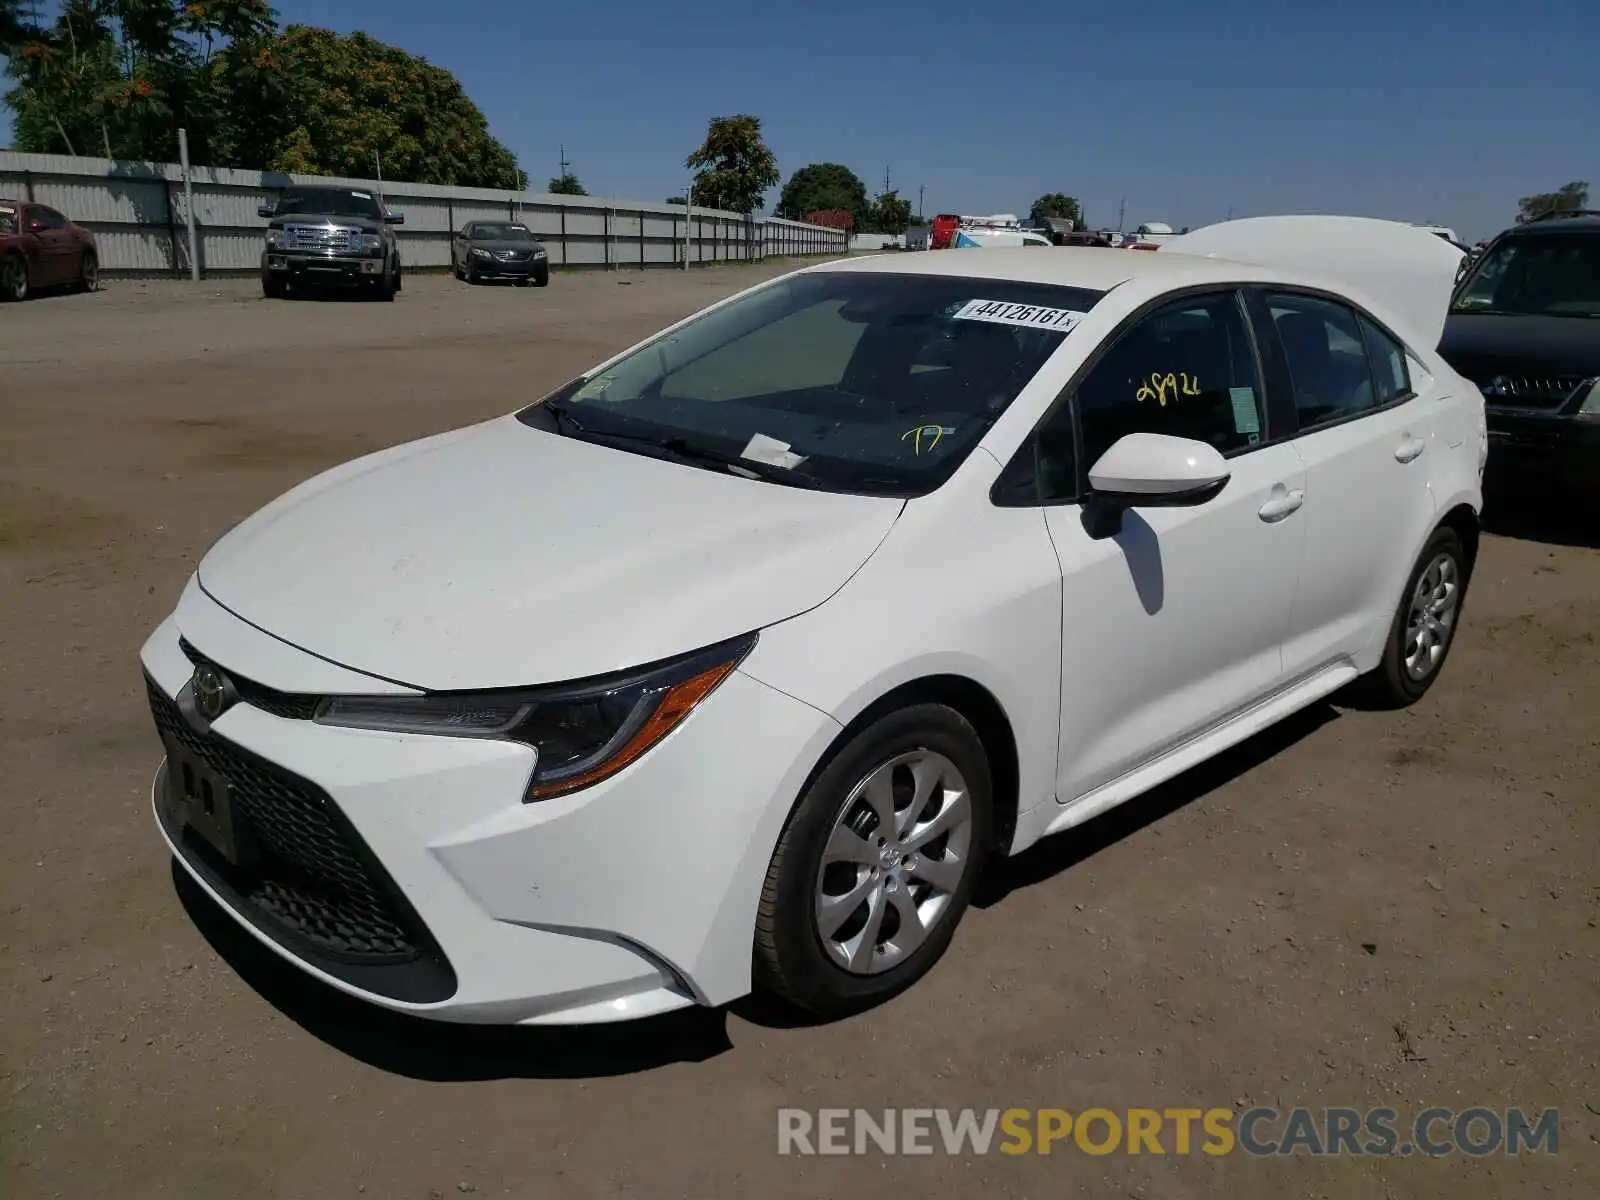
xmin=141 ymin=604 xmax=838 ymax=1024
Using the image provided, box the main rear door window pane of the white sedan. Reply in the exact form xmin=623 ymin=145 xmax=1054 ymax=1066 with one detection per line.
xmin=1264 ymin=291 xmax=1376 ymax=430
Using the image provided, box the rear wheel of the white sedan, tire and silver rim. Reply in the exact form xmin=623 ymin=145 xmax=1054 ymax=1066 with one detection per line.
xmin=1360 ymin=528 xmax=1470 ymax=709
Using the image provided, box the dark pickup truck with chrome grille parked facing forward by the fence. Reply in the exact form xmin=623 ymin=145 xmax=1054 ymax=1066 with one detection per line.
xmin=256 ymin=186 xmax=405 ymax=301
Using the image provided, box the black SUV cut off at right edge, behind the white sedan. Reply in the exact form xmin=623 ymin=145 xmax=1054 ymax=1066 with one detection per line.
xmin=1438 ymin=213 xmax=1600 ymax=508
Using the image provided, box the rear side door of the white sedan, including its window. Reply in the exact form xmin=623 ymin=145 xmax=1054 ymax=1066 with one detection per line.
xmin=1251 ymin=288 xmax=1442 ymax=678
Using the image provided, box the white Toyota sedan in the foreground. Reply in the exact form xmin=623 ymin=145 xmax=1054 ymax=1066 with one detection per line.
xmin=141 ymin=240 xmax=1486 ymax=1024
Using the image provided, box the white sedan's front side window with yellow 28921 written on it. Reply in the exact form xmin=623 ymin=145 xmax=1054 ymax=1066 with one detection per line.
xmin=1074 ymin=291 xmax=1266 ymax=470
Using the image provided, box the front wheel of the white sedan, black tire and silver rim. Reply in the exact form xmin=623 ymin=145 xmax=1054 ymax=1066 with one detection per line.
xmin=755 ymin=704 xmax=992 ymax=1018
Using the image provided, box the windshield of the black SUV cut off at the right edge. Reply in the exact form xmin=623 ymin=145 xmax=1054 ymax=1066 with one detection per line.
xmin=1450 ymin=234 xmax=1600 ymax=317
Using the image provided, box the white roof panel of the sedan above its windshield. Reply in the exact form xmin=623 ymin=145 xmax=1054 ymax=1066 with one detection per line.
xmin=810 ymin=246 xmax=1305 ymax=291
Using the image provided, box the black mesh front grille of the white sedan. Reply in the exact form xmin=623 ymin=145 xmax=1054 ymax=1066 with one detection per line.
xmin=146 ymin=678 xmax=454 ymax=1000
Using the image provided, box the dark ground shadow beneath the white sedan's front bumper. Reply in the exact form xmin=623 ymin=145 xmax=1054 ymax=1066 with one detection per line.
xmin=171 ymin=861 xmax=733 ymax=1083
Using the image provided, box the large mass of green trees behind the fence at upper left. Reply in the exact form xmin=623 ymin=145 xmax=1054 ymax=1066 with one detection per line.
xmin=0 ymin=0 xmax=523 ymax=189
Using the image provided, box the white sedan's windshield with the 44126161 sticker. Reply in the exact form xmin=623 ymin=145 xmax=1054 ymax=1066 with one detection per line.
xmin=522 ymin=272 xmax=1104 ymax=496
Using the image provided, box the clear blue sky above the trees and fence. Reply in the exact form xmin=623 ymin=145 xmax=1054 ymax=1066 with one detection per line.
xmin=6 ymin=0 xmax=1600 ymax=238
